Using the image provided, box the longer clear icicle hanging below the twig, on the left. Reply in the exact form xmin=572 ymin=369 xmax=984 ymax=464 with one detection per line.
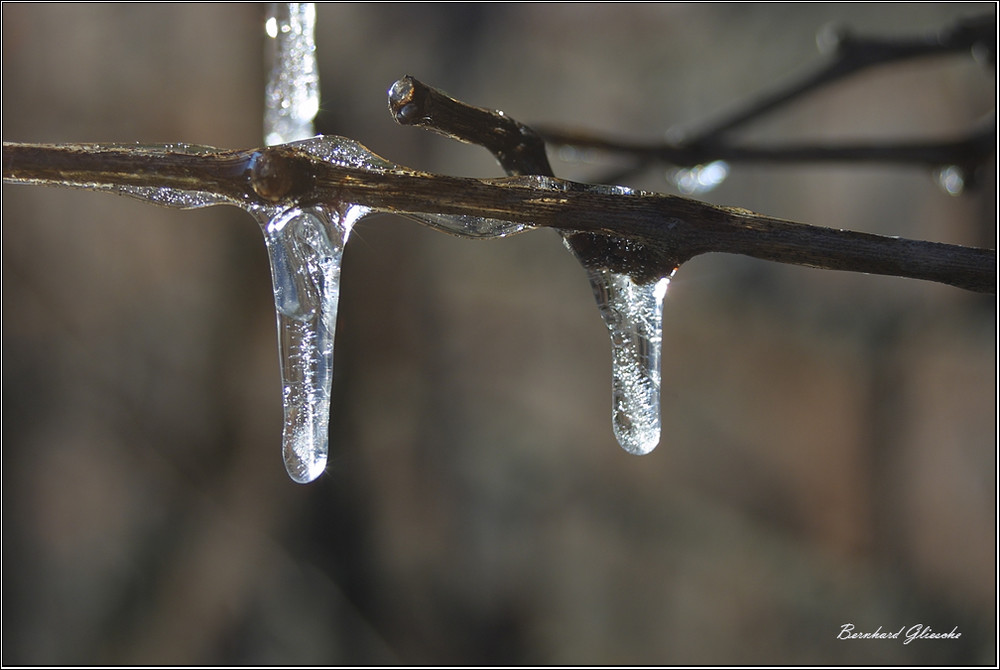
xmin=255 ymin=205 xmax=370 ymax=483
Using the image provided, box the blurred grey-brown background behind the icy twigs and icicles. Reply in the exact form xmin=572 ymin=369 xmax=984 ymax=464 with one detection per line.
xmin=2 ymin=3 xmax=997 ymax=664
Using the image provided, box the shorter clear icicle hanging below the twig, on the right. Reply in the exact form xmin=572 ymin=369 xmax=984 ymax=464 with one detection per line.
xmin=587 ymin=269 xmax=670 ymax=454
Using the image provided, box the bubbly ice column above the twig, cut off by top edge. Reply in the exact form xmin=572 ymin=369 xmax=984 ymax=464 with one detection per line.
xmin=264 ymin=3 xmax=319 ymax=145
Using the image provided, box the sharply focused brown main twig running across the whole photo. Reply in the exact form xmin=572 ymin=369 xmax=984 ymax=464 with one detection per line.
xmin=3 ymin=143 xmax=996 ymax=293
